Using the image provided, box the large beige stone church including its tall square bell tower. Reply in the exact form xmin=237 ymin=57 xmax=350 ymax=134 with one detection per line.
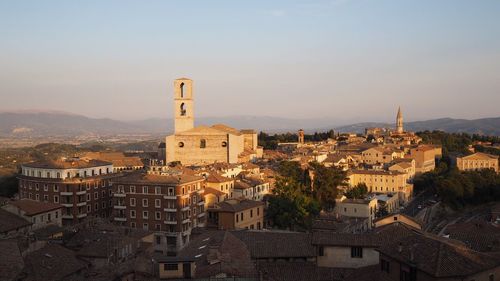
xmin=165 ymin=78 xmax=262 ymax=165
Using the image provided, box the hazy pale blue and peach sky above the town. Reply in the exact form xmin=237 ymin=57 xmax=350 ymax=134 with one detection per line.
xmin=0 ymin=0 xmax=500 ymax=121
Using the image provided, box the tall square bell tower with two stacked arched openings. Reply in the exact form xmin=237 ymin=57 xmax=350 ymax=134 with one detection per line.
xmin=174 ymin=78 xmax=194 ymax=134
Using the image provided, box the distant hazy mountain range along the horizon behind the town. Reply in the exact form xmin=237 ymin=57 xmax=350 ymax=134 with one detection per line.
xmin=0 ymin=111 xmax=500 ymax=138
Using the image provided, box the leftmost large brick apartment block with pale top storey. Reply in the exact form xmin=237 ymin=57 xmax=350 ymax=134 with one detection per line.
xmin=18 ymin=158 xmax=119 ymax=225
